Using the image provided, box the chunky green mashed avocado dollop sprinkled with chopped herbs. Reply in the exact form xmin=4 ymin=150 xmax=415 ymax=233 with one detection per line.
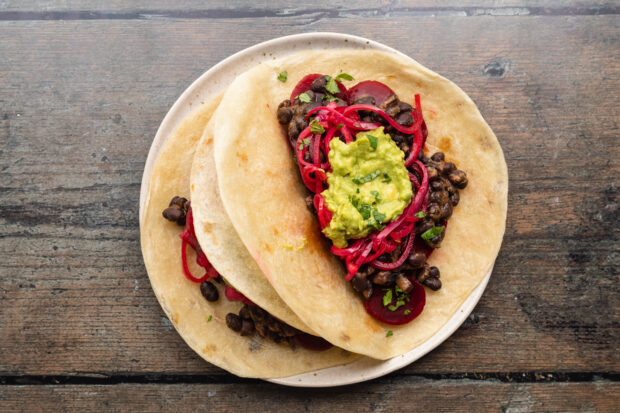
xmin=322 ymin=127 xmax=412 ymax=248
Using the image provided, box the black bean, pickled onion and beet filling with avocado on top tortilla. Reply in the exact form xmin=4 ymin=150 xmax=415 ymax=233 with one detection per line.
xmin=277 ymin=73 xmax=467 ymax=325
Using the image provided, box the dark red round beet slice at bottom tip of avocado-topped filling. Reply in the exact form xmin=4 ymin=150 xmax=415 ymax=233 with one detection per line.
xmin=364 ymin=277 xmax=426 ymax=325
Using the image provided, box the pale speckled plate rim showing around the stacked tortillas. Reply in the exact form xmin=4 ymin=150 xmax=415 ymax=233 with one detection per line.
xmin=139 ymin=32 xmax=495 ymax=387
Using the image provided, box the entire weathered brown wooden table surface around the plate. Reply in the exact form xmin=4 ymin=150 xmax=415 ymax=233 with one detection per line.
xmin=0 ymin=0 xmax=620 ymax=412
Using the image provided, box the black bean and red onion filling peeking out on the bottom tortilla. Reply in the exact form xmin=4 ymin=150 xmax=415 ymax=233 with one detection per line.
xmin=162 ymin=196 xmax=332 ymax=351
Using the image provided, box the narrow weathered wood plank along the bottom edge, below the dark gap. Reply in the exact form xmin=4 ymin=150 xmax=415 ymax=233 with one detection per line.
xmin=0 ymin=378 xmax=620 ymax=413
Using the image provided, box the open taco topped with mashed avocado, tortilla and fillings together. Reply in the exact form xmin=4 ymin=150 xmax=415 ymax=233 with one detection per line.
xmin=208 ymin=49 xmax=508 ymax=359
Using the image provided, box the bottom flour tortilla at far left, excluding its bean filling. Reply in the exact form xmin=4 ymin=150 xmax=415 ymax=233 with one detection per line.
xmin=140 ymin=97 xmax=358 ymax=378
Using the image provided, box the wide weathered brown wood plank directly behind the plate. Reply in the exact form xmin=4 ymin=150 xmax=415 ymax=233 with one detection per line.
xmin=0 ymin=16 xmax=620 ymax=374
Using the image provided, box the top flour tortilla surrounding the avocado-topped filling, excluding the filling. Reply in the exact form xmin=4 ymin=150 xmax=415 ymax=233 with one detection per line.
xmin=214 ymin=49 xmax=508 ymax=359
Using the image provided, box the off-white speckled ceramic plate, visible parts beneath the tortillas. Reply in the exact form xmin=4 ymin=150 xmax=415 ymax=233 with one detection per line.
xmin=140 ymin=33 xmax=492 ymax=387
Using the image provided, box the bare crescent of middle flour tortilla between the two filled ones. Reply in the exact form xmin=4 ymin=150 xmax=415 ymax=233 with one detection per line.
xmin=190 ymin=117 xmax=315 ymax=334
